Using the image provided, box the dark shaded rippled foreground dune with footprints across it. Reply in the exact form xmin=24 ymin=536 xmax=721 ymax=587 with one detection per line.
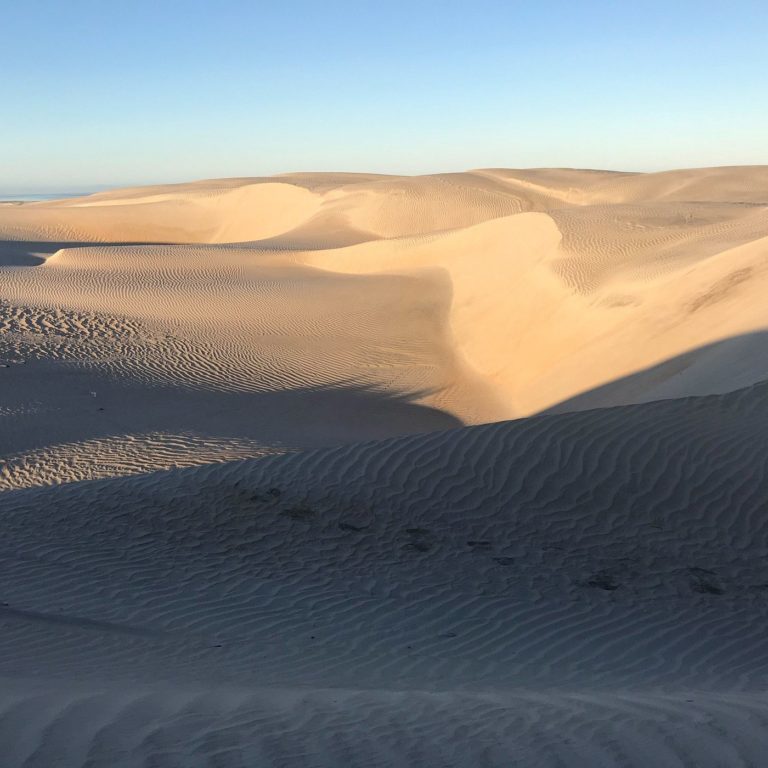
xmin=0 ymin=385 xmax=768 ymax=766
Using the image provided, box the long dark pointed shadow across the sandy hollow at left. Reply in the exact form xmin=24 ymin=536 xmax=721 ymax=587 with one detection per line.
xmin=0 ymin=360 xmax=463 ymax=458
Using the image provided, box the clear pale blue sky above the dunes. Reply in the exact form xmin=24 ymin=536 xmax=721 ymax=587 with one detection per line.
xmin=0 ymin=0 xmax=768 ymax=191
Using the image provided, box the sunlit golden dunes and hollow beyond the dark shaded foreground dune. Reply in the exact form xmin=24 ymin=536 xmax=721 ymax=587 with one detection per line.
xmin=0 ymin=167 xmax=768 ymax=488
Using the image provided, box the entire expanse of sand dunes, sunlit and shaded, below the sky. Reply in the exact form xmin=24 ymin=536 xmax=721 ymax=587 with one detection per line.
xmin=0 ymin=167 xmax=768 ymax=768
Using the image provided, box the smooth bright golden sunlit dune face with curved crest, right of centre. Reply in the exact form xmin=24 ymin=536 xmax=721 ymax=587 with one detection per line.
xmin=305 ymin=206 xmax=768 ymax=418
